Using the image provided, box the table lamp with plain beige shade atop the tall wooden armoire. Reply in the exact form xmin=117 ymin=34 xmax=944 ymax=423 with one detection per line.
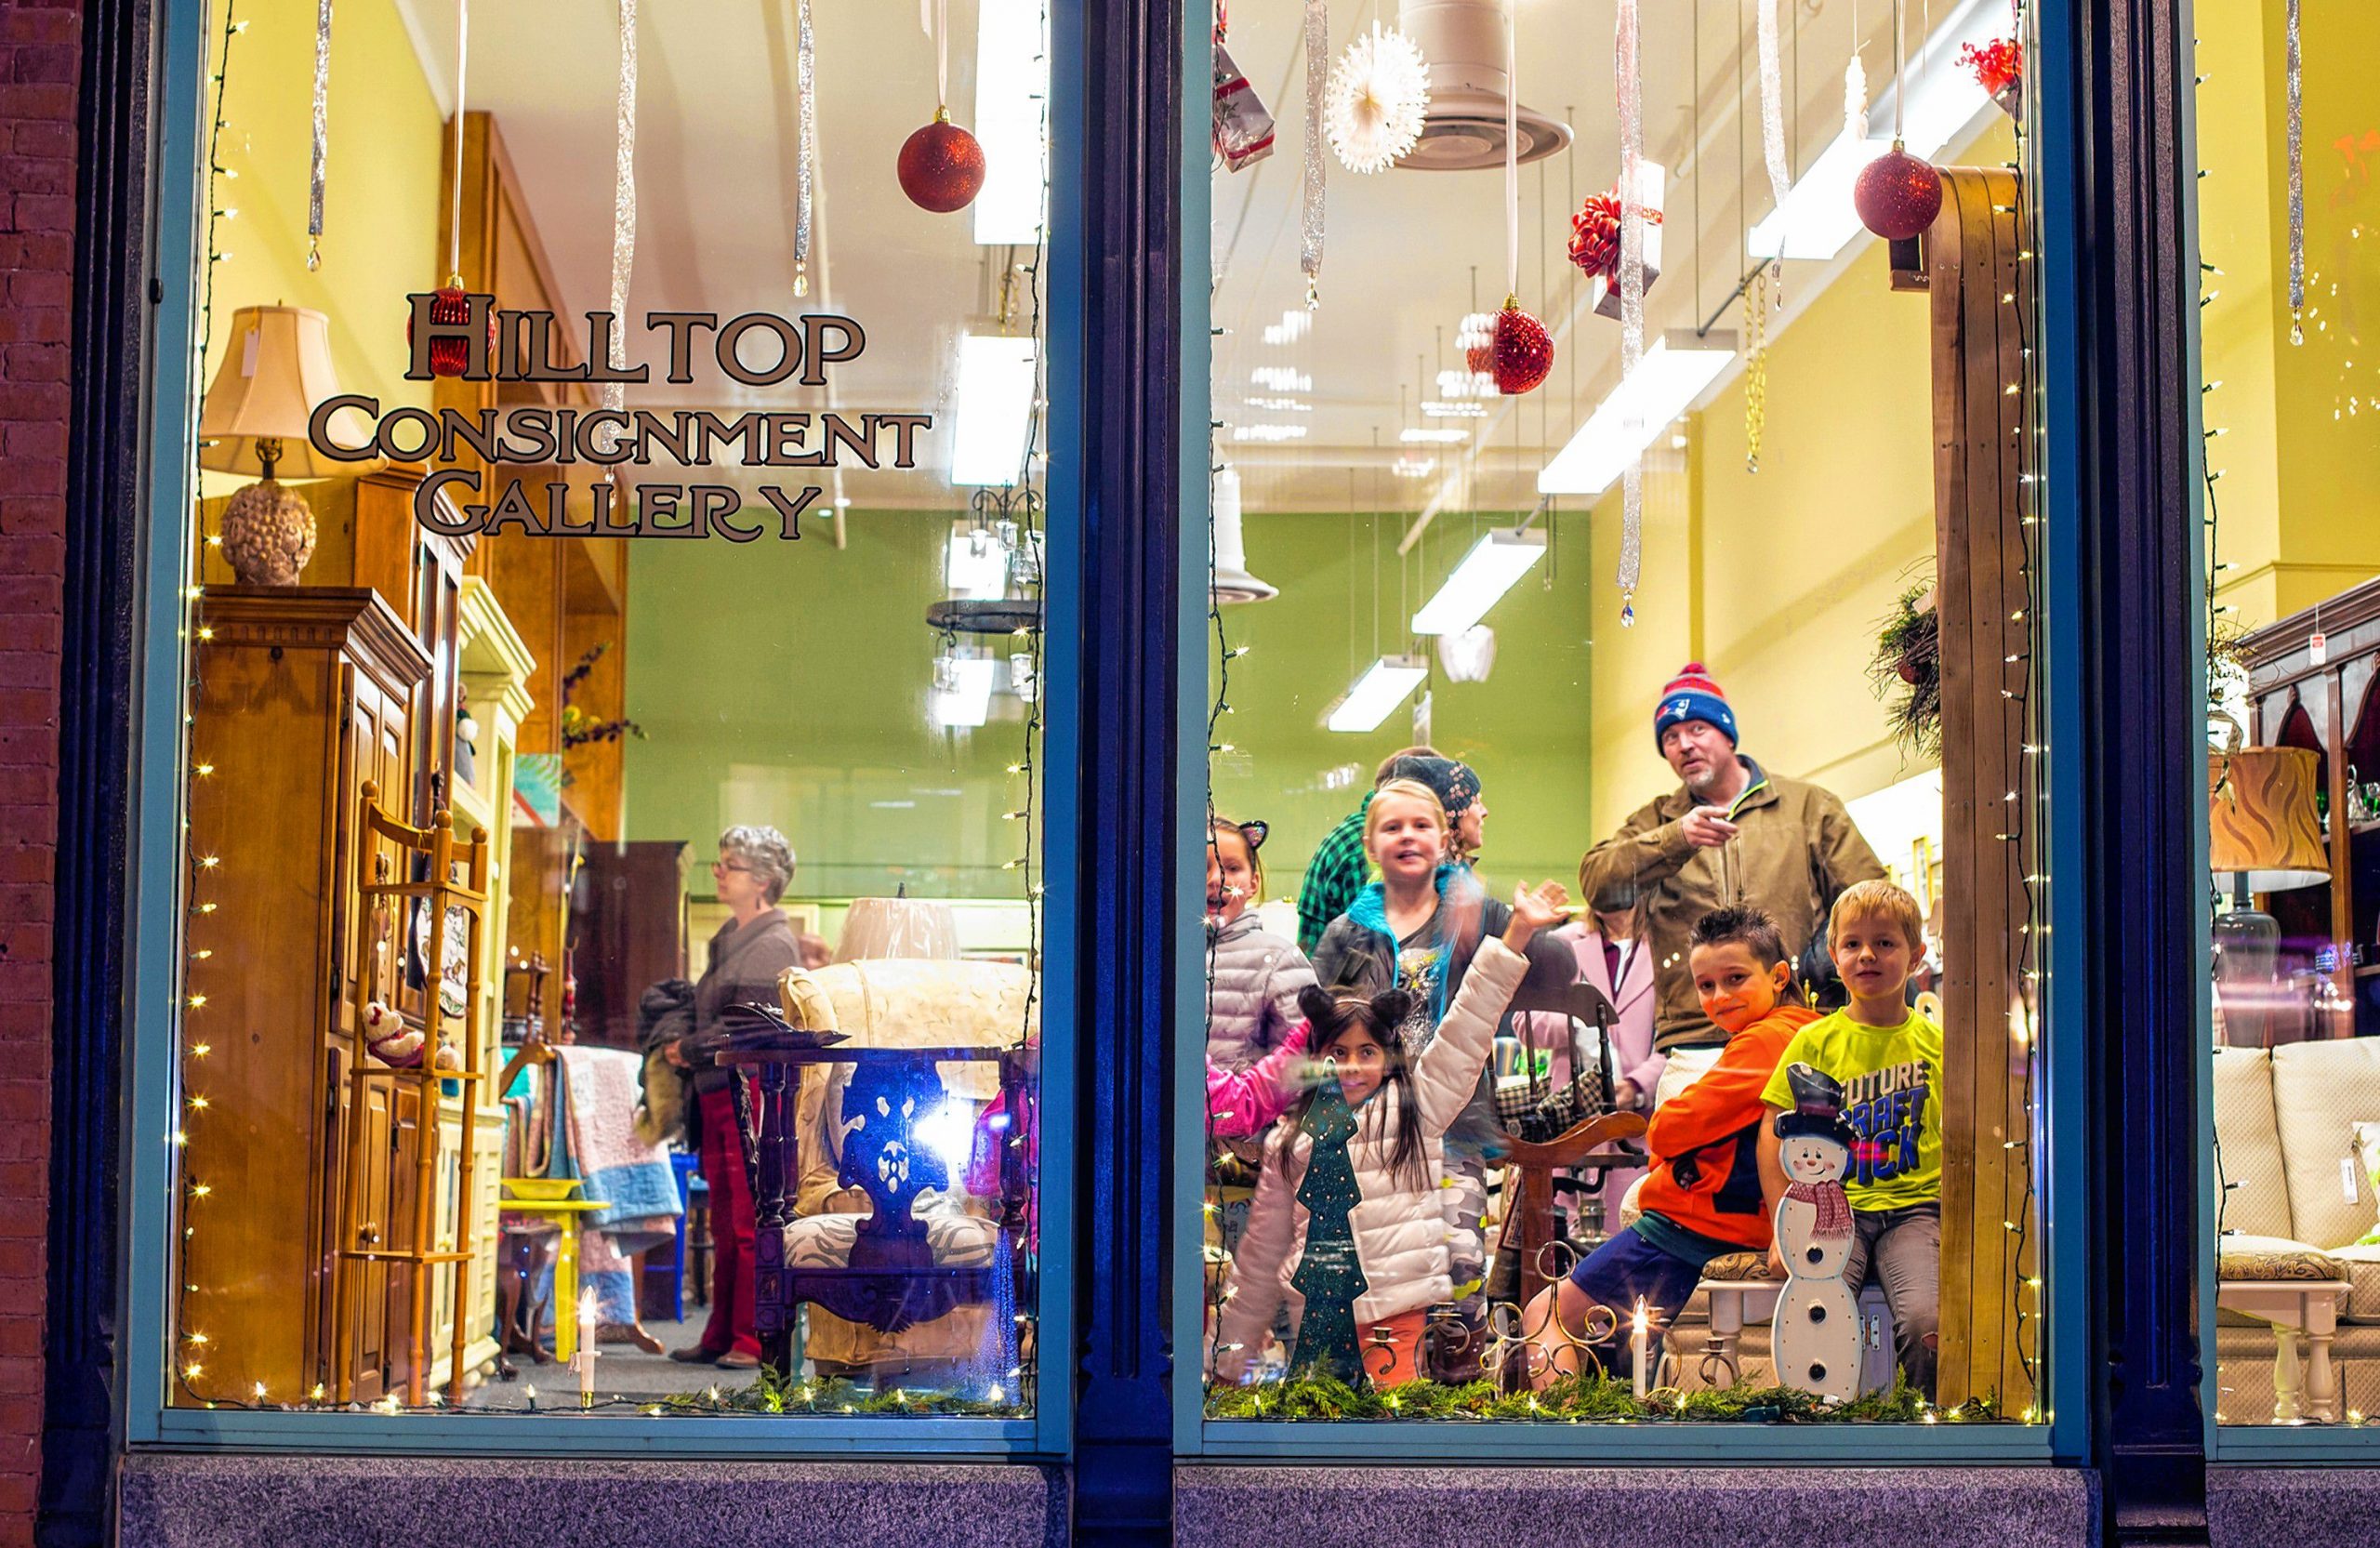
xmin=197 ymin=307 xmax=381 ymax=586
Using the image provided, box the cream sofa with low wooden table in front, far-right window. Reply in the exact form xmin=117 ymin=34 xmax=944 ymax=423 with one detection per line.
xmin=2214 ymin=1039 xmax=2380 ymax=1424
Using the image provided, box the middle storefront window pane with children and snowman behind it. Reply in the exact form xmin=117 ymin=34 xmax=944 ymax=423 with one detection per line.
xmin=1202 ymin=0 xmax=2056 ymax=1426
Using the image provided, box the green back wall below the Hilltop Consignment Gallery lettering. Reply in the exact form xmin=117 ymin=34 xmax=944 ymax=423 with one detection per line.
xmin=626 ymin=512 xmax=1042 ymax=898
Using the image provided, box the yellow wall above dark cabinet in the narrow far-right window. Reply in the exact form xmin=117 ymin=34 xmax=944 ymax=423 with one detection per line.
xmin=2197 ymin=0 xmax=2380 ymax=628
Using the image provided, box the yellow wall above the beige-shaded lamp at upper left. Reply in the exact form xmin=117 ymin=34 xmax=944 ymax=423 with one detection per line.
xmin=205 ymin=0 xmax=445 ymax=493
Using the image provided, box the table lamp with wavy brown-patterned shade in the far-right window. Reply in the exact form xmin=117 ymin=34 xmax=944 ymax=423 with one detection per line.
xmin=2206 ymin=748 xmax=2330 ymax=1048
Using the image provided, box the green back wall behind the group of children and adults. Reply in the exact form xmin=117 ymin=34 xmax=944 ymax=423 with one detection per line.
xmin=1214 ymin=512 xmax=1590 ymax=898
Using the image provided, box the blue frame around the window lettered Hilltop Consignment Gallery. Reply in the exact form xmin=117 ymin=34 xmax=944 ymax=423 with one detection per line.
xmin=119 ymin=0 xmax=1088 ymax=1460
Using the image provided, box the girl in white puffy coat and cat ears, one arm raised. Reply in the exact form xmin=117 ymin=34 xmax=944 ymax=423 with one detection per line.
xmin=1214 ymin=881 xmax=1568 ymax=1386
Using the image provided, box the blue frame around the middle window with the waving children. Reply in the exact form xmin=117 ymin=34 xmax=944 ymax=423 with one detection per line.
xmin=1171 ymin=0 xmax=2084 ymax=1467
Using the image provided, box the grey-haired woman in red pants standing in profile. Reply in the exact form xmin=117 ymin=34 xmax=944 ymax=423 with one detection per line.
xmin=668 ymin=827 xmax=802 ymax=1369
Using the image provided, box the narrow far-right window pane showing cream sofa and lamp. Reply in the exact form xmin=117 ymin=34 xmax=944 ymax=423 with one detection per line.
xmin=2194 ymin=0 xmax=2380 ymax=1426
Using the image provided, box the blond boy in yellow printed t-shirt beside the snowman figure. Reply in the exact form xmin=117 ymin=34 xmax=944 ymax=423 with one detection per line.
xmin=1761 ymin=881 xmax=1942 ymax=1398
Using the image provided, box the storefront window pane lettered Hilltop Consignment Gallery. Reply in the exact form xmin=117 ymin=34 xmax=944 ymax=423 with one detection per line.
xmin=140 ymin=0 xmax=1051 ymax=1424
